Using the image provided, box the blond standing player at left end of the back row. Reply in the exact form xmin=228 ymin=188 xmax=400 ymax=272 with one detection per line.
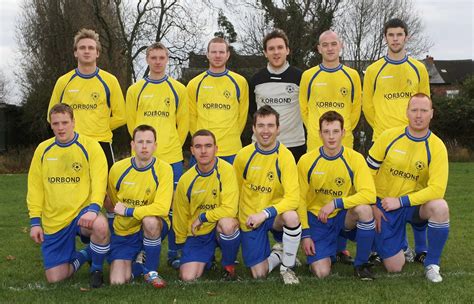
xmin=48 ymin=29 xmax=126 ymax=169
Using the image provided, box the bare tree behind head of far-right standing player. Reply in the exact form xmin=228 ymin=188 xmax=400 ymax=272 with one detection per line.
xmin=335 ymin=0 xmax=433 ymax=72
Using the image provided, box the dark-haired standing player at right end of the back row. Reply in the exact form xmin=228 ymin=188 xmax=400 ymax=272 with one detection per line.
xmin=362 ymin=19 xmax=430 ymax=263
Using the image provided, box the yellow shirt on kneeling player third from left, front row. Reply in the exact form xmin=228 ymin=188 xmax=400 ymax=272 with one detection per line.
xmin=173 ymin=158 xmax=239 ymax=244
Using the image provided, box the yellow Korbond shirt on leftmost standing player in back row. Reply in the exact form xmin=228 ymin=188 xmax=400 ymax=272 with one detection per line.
xmin=47 ymin=68 xmax=126 ymax=142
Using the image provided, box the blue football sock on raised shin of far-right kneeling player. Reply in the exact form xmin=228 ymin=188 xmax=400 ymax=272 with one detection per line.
xmin=425 ymin=221 xmax=449 ymax=266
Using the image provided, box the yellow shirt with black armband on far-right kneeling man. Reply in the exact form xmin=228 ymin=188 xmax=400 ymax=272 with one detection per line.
xmin=367 ymin=127 xmax=448 ymax=207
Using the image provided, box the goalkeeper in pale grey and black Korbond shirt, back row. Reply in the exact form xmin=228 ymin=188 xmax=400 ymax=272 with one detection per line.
xmin=249 ymin=29 xmax=306 ymax=161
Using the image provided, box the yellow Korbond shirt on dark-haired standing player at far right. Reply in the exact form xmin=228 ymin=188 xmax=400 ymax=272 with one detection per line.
xmin=362 ymin=56 xmax=430 ymax=141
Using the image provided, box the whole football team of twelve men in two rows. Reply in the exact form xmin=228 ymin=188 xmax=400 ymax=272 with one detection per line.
xmin=27 ymin=19 xmax=449 ymax=288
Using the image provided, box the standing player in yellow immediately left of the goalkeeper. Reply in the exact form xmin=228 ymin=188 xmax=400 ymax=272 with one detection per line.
xmin=187 ymin=37 xmax=249 ymax=163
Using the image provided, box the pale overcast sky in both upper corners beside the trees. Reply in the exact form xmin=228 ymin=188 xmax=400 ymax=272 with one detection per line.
xmin=0 ymin=0 xmax=474 ymax=103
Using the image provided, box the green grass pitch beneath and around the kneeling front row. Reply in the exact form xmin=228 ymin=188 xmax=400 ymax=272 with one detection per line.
xmin=0 ymin=163 xmax=474 ymax=303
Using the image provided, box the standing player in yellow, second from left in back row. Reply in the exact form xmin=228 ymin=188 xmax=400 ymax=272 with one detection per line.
xmin=126 ymin=42 xmax=189 ymax=268
